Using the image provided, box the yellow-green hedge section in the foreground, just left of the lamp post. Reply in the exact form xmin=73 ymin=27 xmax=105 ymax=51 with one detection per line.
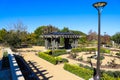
xmin=64 ymin=63 xmax=93 ymax=80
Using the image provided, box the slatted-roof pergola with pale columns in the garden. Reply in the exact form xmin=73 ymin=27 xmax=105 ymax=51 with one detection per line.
xmin=42 ymin=32 xmax=80 ymax=49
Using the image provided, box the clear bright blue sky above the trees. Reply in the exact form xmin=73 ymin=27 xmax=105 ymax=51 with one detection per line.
xmin=0 ymin=0 xmax=120 ymax=35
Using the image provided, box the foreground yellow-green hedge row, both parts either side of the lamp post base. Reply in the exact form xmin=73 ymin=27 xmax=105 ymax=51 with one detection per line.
xmin=64 ymin=63 xmax=120 ymax=80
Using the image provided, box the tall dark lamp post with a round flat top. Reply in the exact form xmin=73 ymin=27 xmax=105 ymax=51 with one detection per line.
xmin=93 ymin=2 xmax=107 ymax=80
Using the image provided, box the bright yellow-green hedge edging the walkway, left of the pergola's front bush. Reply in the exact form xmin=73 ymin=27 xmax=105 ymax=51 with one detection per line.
xmin=38 ymin=52 xmax=57 ymax=65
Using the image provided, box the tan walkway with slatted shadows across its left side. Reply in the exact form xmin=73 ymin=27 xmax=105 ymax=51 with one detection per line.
xmin=23 ymin=53 xmax=83 ymax=80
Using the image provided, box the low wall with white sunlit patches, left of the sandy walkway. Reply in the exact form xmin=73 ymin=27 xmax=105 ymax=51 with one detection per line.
xmin=8 ymin=54 xmax=25 ymax=80
